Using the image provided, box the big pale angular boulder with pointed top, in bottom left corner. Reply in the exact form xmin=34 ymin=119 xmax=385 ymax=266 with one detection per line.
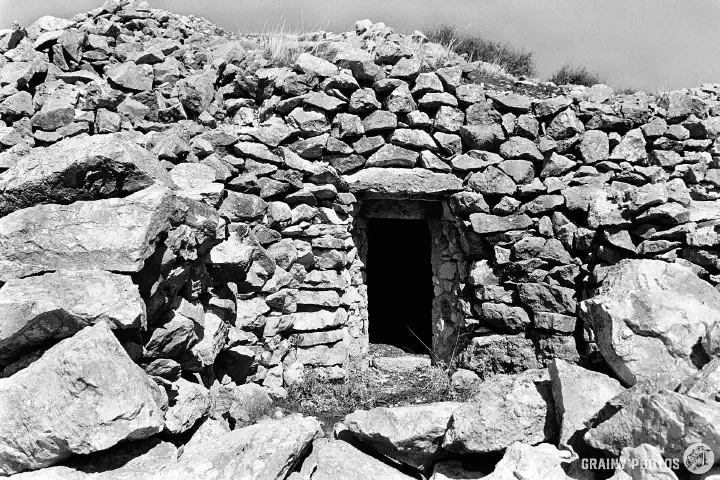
xmin=0 ymin=322 xmax=164 ymax=475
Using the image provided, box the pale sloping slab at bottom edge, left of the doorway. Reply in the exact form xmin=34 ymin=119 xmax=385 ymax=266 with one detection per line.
xmin=156 ymin=414 xmax=322 ymax=480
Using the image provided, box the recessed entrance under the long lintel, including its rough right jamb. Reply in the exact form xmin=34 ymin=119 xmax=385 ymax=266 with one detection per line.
xmin=353 ymin=199 xmax=466 ymax=358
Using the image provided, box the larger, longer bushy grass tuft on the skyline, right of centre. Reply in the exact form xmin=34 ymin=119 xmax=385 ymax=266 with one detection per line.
xmin=426 ymin=25 xmax=536 ymax=77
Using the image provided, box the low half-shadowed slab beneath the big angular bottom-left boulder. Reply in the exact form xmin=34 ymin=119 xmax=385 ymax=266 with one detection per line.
xmin=12 ymin=438 xmax=178 ymax=480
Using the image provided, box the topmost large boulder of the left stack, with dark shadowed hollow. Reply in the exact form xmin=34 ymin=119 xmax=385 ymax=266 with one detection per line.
xmin=0 ymin=134 xmax=173 ymax=216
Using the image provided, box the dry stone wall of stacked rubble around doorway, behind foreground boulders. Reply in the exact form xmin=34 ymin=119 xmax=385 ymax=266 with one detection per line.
xmin=0 ymin=0 xmax=720 ymax=398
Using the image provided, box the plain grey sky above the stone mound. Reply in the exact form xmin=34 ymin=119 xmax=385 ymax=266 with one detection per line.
xmin=0 ymin=0 xmax=720 ymax=92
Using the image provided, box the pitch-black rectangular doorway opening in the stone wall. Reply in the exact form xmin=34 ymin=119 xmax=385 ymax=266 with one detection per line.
xmin=366 ymin=218 xmax=433 ymax=354
